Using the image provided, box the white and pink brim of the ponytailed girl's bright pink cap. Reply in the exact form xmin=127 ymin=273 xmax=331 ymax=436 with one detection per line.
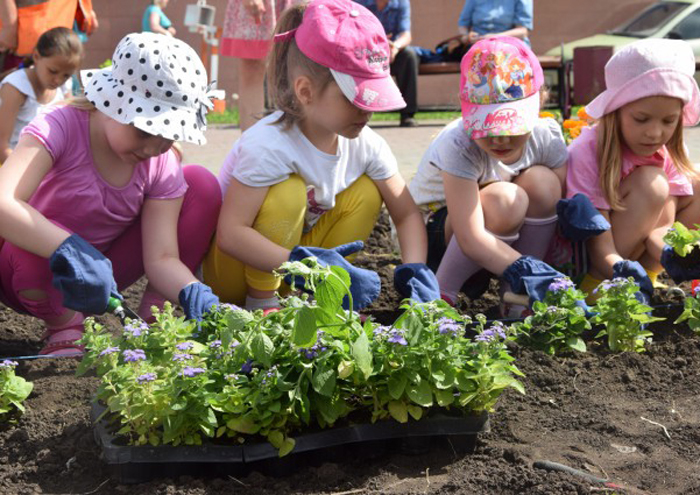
xmin=331 ymin=69 xmax=406 ymax=112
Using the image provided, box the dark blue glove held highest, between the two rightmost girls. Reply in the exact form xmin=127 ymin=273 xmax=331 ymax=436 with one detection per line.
xmin=557 ymin=193 xmax=610 ymax=241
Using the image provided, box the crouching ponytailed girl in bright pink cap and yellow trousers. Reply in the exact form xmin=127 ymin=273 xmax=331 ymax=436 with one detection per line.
xmin=204 ymin=0 xmax=439 ymax=309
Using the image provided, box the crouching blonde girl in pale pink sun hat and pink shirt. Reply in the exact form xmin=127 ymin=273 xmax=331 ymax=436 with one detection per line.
xmin=567 ymin=39 xmax=700 ymax=302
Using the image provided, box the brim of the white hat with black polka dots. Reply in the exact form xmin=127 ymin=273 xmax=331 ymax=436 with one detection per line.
xmin=80 ymin=68 xmax=207 ymax=145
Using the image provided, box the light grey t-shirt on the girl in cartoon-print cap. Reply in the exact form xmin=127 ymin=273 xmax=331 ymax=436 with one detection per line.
xmin=409 ymin=118 xmax=567 ymax=210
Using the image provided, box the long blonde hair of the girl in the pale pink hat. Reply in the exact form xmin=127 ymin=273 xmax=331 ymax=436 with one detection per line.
xmin=597 ymin=109 xmax=698 ymax=210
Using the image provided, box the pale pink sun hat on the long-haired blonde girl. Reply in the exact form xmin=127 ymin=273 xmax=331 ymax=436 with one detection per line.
xmin=586 ymin=38 xmax=700 ymax=125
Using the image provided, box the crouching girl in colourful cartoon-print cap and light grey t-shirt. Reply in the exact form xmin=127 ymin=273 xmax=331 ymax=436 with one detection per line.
xmin=410 ymin=36 xmax=566 ymax=317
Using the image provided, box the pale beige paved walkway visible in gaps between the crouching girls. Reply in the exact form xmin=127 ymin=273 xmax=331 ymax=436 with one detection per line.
xmin=183 ymin=121 xmax=700 ymax=181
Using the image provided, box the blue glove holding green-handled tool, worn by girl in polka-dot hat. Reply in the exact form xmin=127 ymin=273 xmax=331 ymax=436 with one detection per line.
xmin=49 ymin=234 xmax=122 ymax=315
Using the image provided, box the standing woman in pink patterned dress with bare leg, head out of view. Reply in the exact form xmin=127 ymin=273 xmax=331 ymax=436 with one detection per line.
xmin=220 ymin=0 xmax=299 ymax=131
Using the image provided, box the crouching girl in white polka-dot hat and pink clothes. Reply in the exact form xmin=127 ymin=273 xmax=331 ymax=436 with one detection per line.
xmin=0 ymin=33 xmax=221 ymax=355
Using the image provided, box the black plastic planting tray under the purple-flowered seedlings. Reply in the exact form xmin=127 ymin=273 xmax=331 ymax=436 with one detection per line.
xmin=91 ymin=404 xmax=489 ymax=483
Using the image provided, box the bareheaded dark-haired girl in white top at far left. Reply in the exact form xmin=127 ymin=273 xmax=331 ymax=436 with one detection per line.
xmin=0 ymin=27 xmax=83 ymax=163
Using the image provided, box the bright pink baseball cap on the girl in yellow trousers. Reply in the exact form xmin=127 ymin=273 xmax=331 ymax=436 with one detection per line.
xmin=275 ymin=0 xmax=406 ymax=112
